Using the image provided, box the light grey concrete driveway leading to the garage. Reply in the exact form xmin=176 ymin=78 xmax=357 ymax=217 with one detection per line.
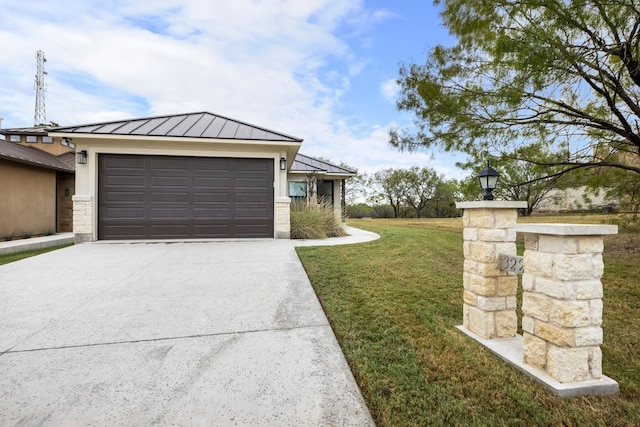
xmin=0 ymin=240 xmax=373 ymax=426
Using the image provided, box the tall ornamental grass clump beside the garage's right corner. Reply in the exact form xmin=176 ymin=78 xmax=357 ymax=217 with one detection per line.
xmin=291 ymin=202 xmax=347 ymax=239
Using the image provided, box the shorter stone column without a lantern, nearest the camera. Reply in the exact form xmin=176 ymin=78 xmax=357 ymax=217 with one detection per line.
xmin=516 ymin=224 xmax=618 ymax=383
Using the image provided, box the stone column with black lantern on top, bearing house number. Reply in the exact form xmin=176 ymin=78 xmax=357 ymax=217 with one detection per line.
xmin=456 ymin=201 xmax=527 ymax=338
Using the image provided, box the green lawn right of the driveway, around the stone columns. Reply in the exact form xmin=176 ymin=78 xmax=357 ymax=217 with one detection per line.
xmin=298 ymin=216 xmax=640 ymax=426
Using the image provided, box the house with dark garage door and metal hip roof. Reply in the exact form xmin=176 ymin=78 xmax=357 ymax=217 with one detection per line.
xmin=48 ymin=112 xmax=354 ymax=242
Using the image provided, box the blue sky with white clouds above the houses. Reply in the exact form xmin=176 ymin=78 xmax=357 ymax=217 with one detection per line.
xmin=0 ymin=0 xmax=463 ymax=178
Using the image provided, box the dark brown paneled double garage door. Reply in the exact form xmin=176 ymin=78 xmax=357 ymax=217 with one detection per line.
xmin=98 ymin=154 xmax=273 ymax=240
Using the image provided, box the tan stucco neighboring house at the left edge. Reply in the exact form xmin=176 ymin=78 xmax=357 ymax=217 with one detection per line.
xmin=0 ymin=137 xmax=75 ymax=239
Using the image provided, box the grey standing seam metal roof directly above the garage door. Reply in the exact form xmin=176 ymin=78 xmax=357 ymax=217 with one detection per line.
xmin=49 ymin=112 xmax=302 ymax=143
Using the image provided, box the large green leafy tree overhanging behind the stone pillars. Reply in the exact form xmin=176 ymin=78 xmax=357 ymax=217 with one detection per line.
xmin=390 ymin=0 xmax=640 ymax=186
